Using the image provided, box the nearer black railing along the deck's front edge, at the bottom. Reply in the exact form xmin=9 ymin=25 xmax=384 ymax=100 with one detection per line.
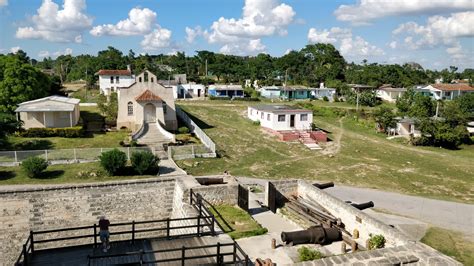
xmin=88 ymin=241 xmax=250 ymax=266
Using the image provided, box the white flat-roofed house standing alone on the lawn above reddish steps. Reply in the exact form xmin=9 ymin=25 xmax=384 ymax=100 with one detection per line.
xmin=247 ymin=105 xmax=313 ymax=131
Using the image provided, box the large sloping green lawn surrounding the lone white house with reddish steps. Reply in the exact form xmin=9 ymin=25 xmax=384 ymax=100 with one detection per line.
xmin=178 ymin=101 xmax=474 ymax=203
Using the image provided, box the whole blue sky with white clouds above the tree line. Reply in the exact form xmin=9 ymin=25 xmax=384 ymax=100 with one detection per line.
xmin=0 ymin=0 xmax=474 ymax=70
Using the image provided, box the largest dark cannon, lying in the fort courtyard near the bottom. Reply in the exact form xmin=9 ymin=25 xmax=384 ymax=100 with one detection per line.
xmin=281 ymin=226 xmax=342 ymax=245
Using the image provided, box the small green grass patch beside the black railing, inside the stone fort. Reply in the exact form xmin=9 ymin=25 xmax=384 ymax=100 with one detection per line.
xmin=211 ymin=205 xmax=268 ymax=239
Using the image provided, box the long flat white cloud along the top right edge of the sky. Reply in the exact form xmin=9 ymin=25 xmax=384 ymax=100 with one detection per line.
xmin=334 ymin=0 xmax=473 ymax=24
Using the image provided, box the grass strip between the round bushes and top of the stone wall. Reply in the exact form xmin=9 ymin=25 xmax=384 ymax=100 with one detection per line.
xmin=0 ymin=162 xmax=153 ymax=185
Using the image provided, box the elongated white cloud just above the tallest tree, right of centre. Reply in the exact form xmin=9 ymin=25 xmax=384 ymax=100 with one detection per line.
xmin=308 ymin=27 xmax=385 ymax=57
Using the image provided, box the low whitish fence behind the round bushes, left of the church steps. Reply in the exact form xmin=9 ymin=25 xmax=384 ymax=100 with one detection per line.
xmin=0 ymin=147 xmax=168 ymax=166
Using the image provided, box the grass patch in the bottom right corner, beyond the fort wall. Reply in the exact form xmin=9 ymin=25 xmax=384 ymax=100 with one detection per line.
xmin=421 ymin=227 xmax=474 ymax=265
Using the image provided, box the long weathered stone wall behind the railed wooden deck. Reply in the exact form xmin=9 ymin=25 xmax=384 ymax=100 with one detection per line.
xmin=0 ymin=178 xmax=175 ymax=265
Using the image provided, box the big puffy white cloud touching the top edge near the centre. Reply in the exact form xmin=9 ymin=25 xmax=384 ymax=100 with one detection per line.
xmin=195 ymin=0 xmax=296 ymax=55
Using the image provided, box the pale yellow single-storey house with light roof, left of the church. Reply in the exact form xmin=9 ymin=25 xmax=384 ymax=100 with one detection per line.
xmin=15 ymin=96 xmax=80 ymax=129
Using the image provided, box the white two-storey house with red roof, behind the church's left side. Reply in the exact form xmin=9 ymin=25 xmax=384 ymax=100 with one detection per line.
xmin=97 ymin=68 xmax=135 ymax=95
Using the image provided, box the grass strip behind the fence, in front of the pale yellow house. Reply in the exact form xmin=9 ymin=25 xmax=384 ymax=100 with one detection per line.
xmin=4 ymin=130 xmax=129 ymax=150
